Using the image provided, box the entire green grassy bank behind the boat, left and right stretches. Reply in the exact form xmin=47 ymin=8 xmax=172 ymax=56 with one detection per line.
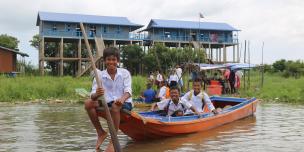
xmin=0 ymin=72 xmax=304 ymax=103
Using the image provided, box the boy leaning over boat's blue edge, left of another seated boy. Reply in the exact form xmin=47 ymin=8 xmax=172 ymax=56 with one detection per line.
xmin=151 ymin=86 xmax=199 ymax=117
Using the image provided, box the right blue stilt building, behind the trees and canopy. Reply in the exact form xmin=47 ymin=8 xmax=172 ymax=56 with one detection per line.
xmin=142 ymin=19 xmax=239 ymax=62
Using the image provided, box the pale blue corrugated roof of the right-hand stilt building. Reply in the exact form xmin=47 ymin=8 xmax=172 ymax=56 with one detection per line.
xmin=146 ymin=19 xmax=239 ymax=31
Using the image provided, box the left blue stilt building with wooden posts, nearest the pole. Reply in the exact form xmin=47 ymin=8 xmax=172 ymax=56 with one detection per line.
xmin=36 ymin=12 xmax=143 ymax=75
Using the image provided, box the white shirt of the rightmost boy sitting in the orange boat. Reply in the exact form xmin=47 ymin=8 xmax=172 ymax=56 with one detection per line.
xmin=181 ymin=90 xmax=215 ymax=114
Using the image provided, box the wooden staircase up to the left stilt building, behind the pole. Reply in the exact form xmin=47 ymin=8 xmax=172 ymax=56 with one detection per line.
xmin=77 ymin=36 xmax=105 ymax=77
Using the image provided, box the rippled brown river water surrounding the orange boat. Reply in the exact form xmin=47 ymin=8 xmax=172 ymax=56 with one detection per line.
xmin=0 ymin=103 xmax=304 ymax=152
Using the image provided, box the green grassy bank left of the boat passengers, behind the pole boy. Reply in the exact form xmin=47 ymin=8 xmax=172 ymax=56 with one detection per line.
xmin=0 ymin=76 xmax=146 ymax=102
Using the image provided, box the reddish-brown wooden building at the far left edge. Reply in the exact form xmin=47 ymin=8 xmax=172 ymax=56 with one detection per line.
xmin=0 ymin=46 xmax=28 ymax=73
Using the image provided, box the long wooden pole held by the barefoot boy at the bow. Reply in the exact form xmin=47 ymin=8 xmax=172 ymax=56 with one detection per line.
xmin=80 ymin=23 xmax=121 ymax=152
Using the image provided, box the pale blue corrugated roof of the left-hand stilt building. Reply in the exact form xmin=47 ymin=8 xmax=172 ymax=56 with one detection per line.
xmin=36 ymin=12 xmax=143 ymax=28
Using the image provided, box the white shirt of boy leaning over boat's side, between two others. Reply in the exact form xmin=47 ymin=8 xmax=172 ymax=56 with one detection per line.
xmin=156 ymin=99 xmax=192 ymax=116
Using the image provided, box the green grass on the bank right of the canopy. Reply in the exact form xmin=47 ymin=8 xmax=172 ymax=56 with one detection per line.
xmin=240 ymin=71 xmax=304 ymax=103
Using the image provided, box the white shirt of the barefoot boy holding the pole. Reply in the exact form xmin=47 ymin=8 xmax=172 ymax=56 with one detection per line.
xmin=91 ymin=68 xmax=132 ymax=103
